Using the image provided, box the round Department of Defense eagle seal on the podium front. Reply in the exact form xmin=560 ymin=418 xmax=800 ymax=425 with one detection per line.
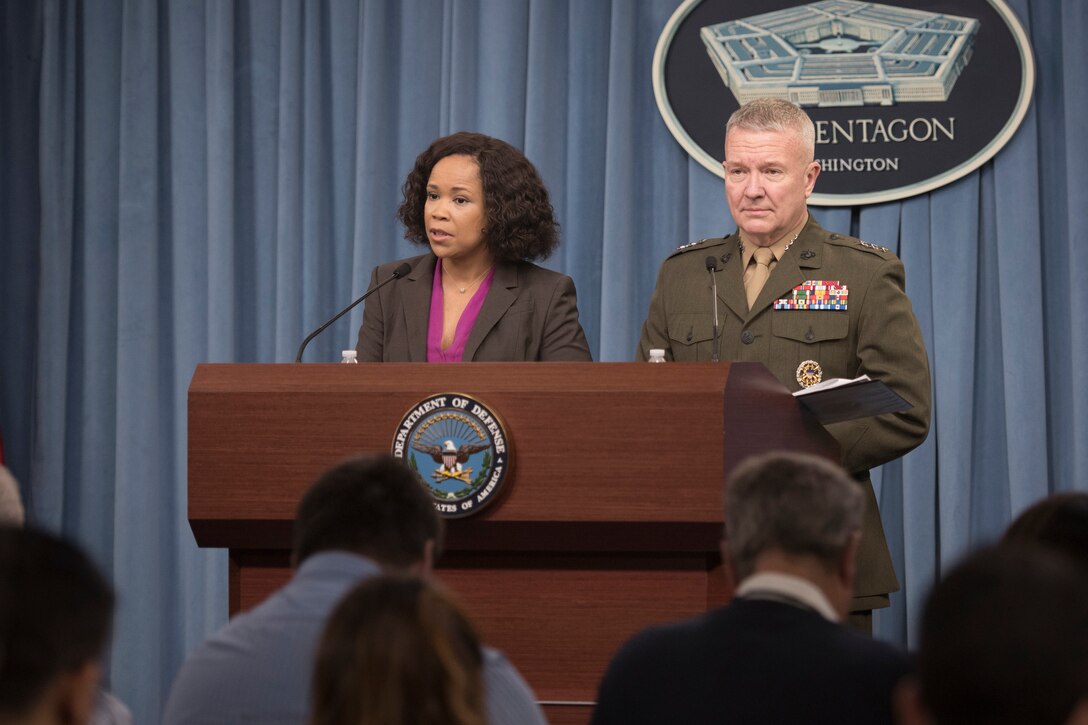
xmin=392 ymin=393 xmax=510 ymax=518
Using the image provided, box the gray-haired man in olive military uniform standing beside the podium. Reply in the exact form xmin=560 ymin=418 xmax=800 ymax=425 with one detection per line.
xmin=638 ymin=99 xmax=930 ymax=628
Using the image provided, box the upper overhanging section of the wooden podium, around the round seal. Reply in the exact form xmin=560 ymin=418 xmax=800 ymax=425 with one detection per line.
xmin=188 ymin=363 xmax=836 ymax=546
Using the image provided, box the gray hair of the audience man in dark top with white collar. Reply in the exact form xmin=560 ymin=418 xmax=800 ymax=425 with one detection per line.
xmin=725 ymin=452 xmax=865 ymax=579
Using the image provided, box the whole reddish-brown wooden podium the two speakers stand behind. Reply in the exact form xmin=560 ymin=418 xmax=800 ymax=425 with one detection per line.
xmin=188 ymin=363 xmax=838 ymax=723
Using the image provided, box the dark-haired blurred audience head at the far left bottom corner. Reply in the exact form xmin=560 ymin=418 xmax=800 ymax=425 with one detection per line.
xmin=0 ymin=526 xmax=113 ymax=724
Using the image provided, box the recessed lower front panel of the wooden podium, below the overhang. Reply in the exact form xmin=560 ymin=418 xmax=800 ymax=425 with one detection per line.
xmin=232 ymin=552 xmax=724 ymax=722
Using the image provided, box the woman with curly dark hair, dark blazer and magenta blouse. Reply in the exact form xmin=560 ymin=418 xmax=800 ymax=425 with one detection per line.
xmin=356 ymin=133 xmax=591 ymax=363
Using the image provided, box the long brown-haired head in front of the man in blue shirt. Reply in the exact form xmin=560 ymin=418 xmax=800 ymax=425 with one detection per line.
xmin=310 ymin=576 xmax=485 ymax=725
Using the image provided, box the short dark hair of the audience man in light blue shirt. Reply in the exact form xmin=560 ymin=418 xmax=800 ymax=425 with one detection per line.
xmin=294 ymin=455 xmax=442 ymax=570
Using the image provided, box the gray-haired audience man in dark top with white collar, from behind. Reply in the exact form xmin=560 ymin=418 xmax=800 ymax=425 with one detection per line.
xmin=592 ymin=453 xmax=908 ymax=725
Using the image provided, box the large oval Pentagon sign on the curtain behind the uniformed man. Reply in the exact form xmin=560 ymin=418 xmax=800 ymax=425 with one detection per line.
xmin=653 ymin=0 xmax=1035 ymax=206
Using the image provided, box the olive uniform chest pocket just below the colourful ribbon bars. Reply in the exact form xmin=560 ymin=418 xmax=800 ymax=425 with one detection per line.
xmin=770 ymin=309 xmax=855 ymax=380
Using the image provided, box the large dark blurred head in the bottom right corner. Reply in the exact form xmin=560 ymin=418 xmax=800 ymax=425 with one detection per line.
xmin=898 ymin=545 xmax=1088 ymax=725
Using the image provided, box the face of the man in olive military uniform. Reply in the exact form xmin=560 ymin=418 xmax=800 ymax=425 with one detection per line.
xmin=722 ymin=128 xmax=819 ymax=247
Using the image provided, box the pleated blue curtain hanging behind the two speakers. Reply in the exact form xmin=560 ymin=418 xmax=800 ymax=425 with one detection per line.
xmin=0 ymin=0 xmax=1088 ymax=722
